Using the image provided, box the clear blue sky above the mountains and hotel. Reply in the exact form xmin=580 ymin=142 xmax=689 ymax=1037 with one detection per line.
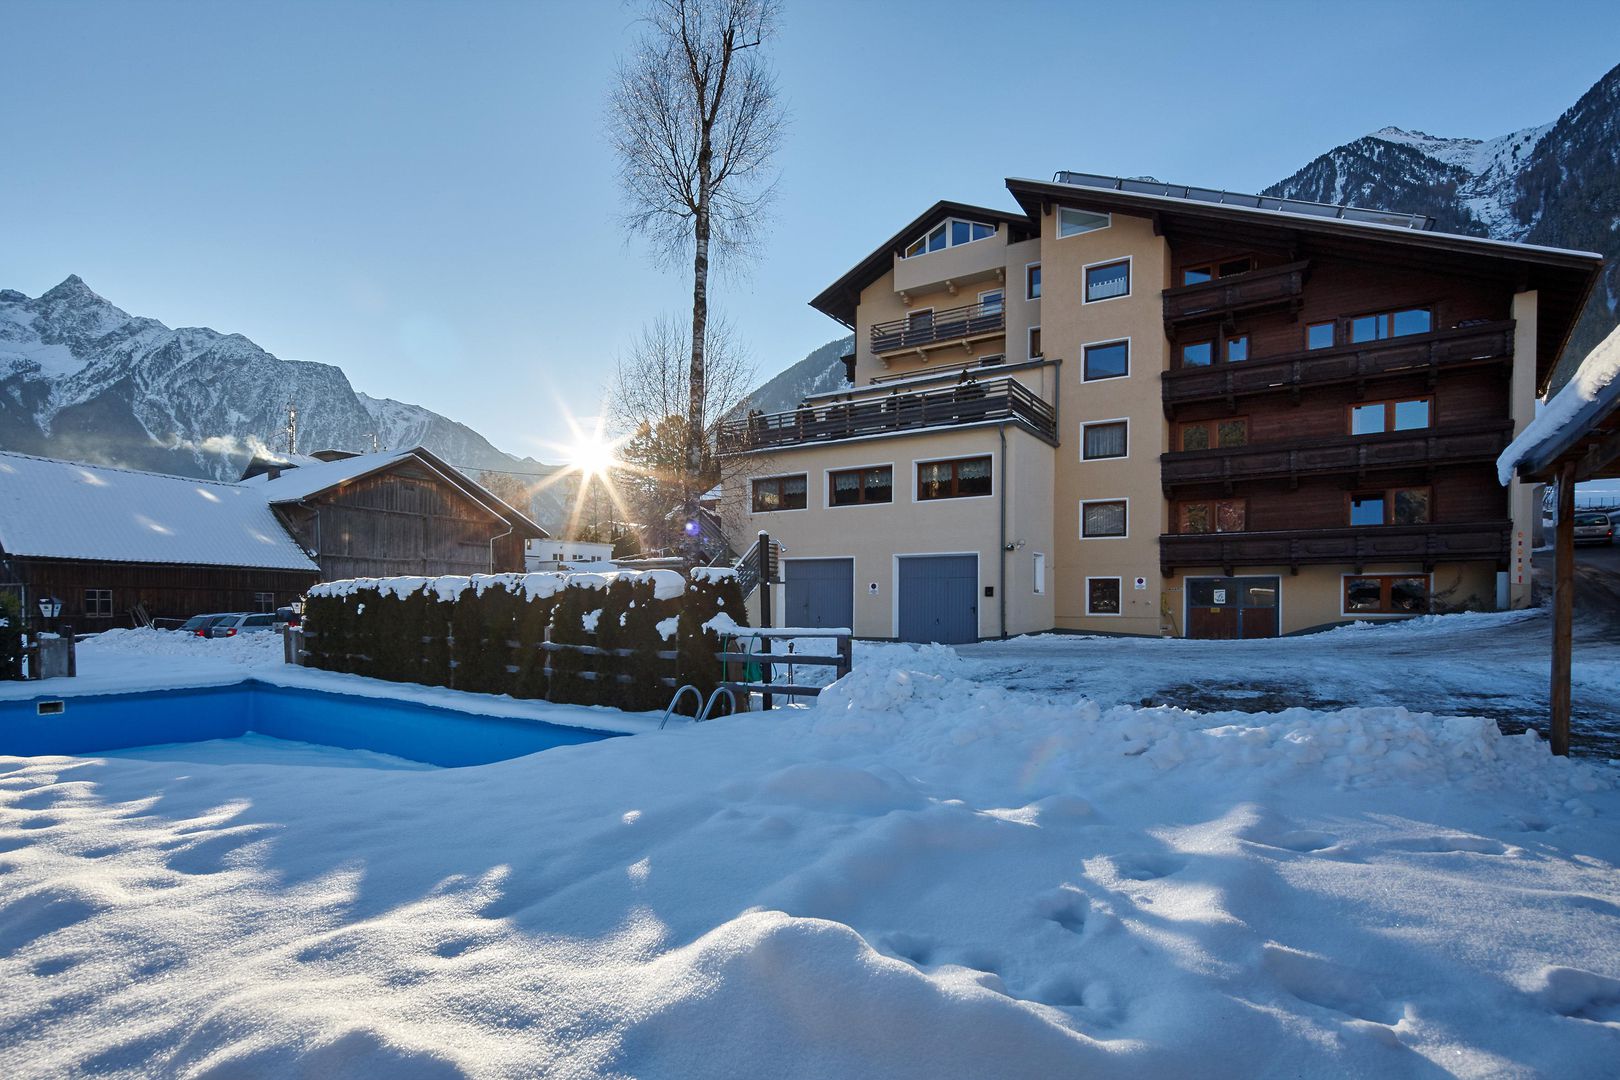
xmin=0 ymin=0 xmax=1620 ymax=458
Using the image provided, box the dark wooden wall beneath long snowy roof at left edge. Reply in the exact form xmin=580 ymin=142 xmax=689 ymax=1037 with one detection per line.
xmin=0 ymin=555 xmax=318 ymax=633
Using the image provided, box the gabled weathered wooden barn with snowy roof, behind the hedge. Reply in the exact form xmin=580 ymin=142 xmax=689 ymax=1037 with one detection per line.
xmin=240 ymin=447 xmax=548 ymax=581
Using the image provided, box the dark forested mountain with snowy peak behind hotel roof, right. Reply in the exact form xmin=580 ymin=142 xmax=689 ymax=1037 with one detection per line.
xmin=1264 ymin=66 xmax=1620 ymax=385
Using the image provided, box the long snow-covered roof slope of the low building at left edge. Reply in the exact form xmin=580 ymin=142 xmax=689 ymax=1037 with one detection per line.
xmin=0 ymin=452 xmax=319 ymax=573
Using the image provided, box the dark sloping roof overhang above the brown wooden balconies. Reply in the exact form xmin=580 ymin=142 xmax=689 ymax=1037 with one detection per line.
xmin=1006 ymin=178 xmax=1602 ymax=390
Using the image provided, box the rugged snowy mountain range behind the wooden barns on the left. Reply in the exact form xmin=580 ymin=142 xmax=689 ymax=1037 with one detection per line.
xmin=0 ymin=275 xmax=570 ymax=525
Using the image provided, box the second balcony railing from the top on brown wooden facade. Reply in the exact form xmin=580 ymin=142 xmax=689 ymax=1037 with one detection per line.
xmin=1163 ymin=321 xmax=1513 ymax=408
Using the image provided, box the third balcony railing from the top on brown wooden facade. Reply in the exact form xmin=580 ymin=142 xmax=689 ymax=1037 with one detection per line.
xmin=1160 ymin=421 xmax=1513 ymax=491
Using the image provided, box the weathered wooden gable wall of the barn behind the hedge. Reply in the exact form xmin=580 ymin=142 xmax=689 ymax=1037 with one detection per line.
xmin=277 ymin=461 xmax=523 ymax=581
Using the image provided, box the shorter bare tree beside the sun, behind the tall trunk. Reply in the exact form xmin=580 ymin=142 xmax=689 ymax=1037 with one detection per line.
xmin=608 ymin=310 xmax=758 ymax=547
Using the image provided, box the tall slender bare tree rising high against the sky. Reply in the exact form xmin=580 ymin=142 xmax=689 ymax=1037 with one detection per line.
xmin=609 ymin=0 xmax=786 ymax=540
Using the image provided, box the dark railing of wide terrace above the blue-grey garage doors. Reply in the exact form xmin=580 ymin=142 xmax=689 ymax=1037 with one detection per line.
xmin=719 ymin=379 xmax=1058 ymax=453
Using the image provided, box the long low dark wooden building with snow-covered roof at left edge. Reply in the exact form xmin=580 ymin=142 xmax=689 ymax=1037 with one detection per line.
xmin=0 ymin=453 xmax=319 ymax=630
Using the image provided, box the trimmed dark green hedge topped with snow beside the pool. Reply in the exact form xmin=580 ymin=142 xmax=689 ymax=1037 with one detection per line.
xmin=305 ymin=568 xmax=722 ymax=711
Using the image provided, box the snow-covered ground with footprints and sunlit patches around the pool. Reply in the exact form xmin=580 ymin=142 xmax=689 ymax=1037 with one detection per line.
xmin=0 ymin=615 xmax=1620 ymax=1078
